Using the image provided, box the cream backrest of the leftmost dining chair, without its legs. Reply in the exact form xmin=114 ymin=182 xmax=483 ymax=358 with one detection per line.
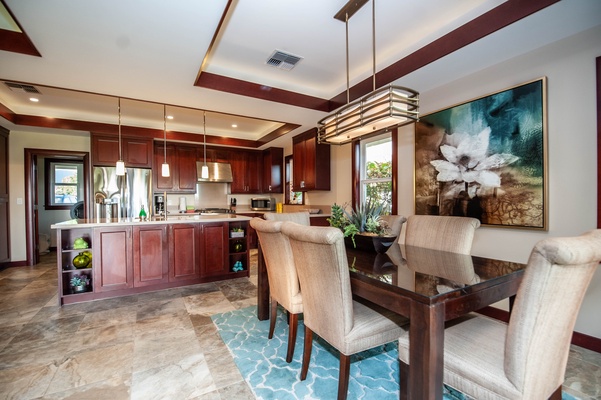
xmin=250 ymin=218 xmax=303 ymax=314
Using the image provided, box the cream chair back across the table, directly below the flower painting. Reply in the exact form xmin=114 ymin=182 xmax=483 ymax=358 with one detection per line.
xmin=405 ymin=215 xmax=480 ymax=254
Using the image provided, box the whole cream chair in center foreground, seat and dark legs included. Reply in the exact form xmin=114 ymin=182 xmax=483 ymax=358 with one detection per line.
xmin=282 ymin=222 xmax=406 ymax=399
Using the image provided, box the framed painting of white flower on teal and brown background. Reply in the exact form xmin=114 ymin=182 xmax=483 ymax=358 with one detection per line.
xmin=415 ymin=77 xmax=548 ymax=230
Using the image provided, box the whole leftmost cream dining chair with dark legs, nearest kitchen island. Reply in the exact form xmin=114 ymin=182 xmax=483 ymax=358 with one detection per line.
xmin=250 ymin=218 xmax=303 ymax=362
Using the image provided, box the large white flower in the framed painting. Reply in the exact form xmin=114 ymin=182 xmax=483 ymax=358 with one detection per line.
xmin=430 ymin=127 xmax=519 ymax=197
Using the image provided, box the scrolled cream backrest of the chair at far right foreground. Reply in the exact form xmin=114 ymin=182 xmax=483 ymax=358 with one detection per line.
xmin=504 ymin=229 xmax=601 ymax=399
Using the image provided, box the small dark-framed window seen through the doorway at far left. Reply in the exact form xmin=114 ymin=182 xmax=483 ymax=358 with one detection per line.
xmin=44 ymin=158 xmax=83 ymax=210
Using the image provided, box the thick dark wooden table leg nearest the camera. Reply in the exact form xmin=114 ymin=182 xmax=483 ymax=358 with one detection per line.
xmin=409 ymin=302 xmax=444 ymax=400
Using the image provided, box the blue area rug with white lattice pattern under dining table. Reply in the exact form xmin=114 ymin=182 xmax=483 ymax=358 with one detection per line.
xmin=212 ymin=306 xmax=575 ymax=400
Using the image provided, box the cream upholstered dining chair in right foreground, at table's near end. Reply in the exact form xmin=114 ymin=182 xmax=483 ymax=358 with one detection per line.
xmin=399 ymin=230 xmax=601 ymax=400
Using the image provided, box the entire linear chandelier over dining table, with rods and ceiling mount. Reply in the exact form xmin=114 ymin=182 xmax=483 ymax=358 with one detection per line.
xmin=317 ymin=0 xmax=419 ymax=145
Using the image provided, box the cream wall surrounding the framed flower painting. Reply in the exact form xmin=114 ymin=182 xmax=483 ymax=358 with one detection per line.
xmin=398 ymin=28 xmax=601 ymax=338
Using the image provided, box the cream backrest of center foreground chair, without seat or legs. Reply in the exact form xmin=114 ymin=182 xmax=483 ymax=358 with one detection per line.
xmin=282 ymin=222 xmax=353 ymax=349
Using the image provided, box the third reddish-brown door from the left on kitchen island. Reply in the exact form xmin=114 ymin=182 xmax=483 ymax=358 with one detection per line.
xmin=169 ymin=224 xmax=201 ymax=282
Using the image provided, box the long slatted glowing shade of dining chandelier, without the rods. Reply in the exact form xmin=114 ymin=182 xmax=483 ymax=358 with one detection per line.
xmin=317 ymin=85 xmax=419 ymax=144
